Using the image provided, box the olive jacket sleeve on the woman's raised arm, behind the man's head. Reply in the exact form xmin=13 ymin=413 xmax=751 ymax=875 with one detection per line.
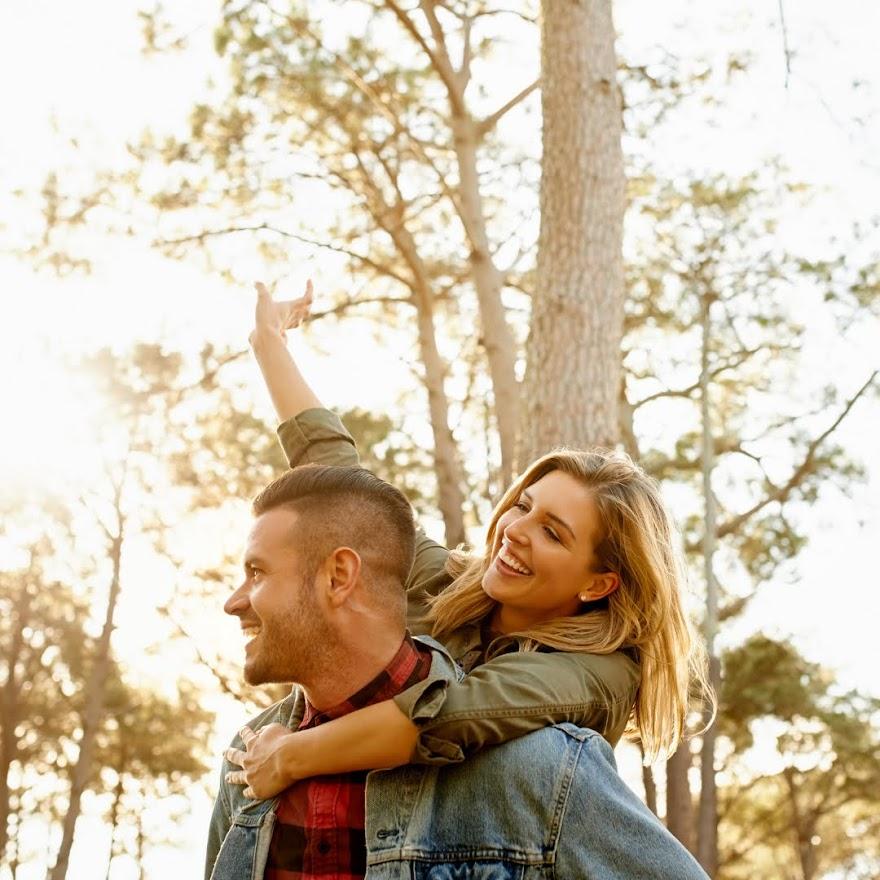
xmin=278 ymin=408 xmax=449 ymax=632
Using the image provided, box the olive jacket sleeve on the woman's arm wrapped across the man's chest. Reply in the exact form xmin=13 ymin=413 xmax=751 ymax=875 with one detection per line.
xmin=394 ymin=651 xmax=639 ymax=764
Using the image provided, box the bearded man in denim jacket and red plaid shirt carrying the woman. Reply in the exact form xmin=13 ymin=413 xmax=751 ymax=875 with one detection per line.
xmin=206 ymin=466 xmax=705 ymax=880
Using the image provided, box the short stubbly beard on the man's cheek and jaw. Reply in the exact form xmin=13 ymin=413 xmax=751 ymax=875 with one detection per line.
xmin=244 ymin=576 xmax=334 ymax=685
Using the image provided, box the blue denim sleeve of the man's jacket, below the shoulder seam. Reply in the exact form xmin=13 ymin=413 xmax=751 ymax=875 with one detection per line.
xmin=556 ymin=736 xmax=709 ymax=880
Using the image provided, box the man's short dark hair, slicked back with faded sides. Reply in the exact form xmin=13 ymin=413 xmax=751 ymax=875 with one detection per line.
xmin=253 ymin=465 xmax=416 ymax=615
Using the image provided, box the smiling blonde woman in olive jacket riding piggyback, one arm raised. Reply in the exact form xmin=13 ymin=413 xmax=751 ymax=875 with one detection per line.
xmin=227 ymin=282 xmax=708 ymax=797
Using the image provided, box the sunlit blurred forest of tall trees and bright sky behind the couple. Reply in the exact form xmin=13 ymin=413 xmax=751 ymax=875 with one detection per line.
xmin=0 ymin=0 xmax=880 ymax=880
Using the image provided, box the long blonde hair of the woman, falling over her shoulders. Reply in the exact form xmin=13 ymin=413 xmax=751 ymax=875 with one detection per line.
xmin=427 ymin=449 xmax=714 ymax=761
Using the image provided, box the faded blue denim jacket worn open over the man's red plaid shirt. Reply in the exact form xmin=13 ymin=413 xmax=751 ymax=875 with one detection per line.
xmin=205 ymin=638 xmax=707 ymax=880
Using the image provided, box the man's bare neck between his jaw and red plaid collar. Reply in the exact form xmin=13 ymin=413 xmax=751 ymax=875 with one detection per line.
xmin=301 ymin=631 xmax=404 ymax=711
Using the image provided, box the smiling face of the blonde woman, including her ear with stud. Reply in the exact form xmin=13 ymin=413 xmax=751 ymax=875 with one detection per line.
xmin=483 ymin=471 xmax=618 ymax=632
